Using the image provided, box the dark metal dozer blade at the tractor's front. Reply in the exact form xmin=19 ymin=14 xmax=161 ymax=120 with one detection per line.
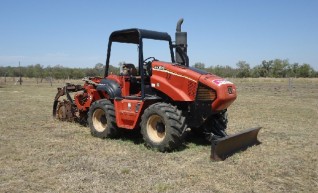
xmin=211 ymin=127 xmax=262 ymax=161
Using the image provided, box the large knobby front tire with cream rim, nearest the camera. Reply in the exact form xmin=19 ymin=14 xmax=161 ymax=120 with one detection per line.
xmin=140 ymin=103 xmax=187 ymax=152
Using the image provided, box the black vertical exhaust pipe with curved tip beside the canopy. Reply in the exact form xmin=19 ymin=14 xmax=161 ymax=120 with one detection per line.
xmin=175 ymin=18 xmax=189 ymax=66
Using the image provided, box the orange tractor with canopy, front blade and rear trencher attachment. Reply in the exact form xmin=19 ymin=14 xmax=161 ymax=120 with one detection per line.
xmin=53 ymin=19 xmax=260 ymax=160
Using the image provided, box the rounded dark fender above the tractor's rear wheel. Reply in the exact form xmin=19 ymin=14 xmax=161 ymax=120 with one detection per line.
xmin=96 ymin=79 xmax=122 ymax=99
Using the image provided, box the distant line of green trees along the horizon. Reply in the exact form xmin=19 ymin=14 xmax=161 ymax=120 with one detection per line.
xmin=0 ymin=59 xmax=318 ymax=82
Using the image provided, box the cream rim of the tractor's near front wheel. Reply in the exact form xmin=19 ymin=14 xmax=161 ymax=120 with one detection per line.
xmin=147 ymin=115 xmax=166 ymax=143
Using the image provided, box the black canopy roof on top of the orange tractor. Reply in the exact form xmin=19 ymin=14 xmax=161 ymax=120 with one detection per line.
xmin=109 ymin=28 xmax=171 ymax=44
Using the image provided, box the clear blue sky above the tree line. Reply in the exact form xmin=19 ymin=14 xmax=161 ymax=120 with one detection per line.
xmin=0 ymin=0 xmax=318 ymax=70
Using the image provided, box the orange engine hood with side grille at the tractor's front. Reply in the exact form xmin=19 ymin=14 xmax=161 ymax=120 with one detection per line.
xmin=151 ymin=61 xmax=237 ymax=112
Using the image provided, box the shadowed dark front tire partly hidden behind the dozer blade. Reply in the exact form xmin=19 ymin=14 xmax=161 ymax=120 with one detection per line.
xmin=202 ymin=110 xmax=228 ymax=142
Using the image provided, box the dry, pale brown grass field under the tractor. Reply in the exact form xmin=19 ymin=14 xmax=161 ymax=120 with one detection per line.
xmin=0 ymin=79 xmax=318 ymax=192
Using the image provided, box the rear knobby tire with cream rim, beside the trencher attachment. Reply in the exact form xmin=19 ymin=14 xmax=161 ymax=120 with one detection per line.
xmin=88 ymin=99 xmax=119 ymax=138
